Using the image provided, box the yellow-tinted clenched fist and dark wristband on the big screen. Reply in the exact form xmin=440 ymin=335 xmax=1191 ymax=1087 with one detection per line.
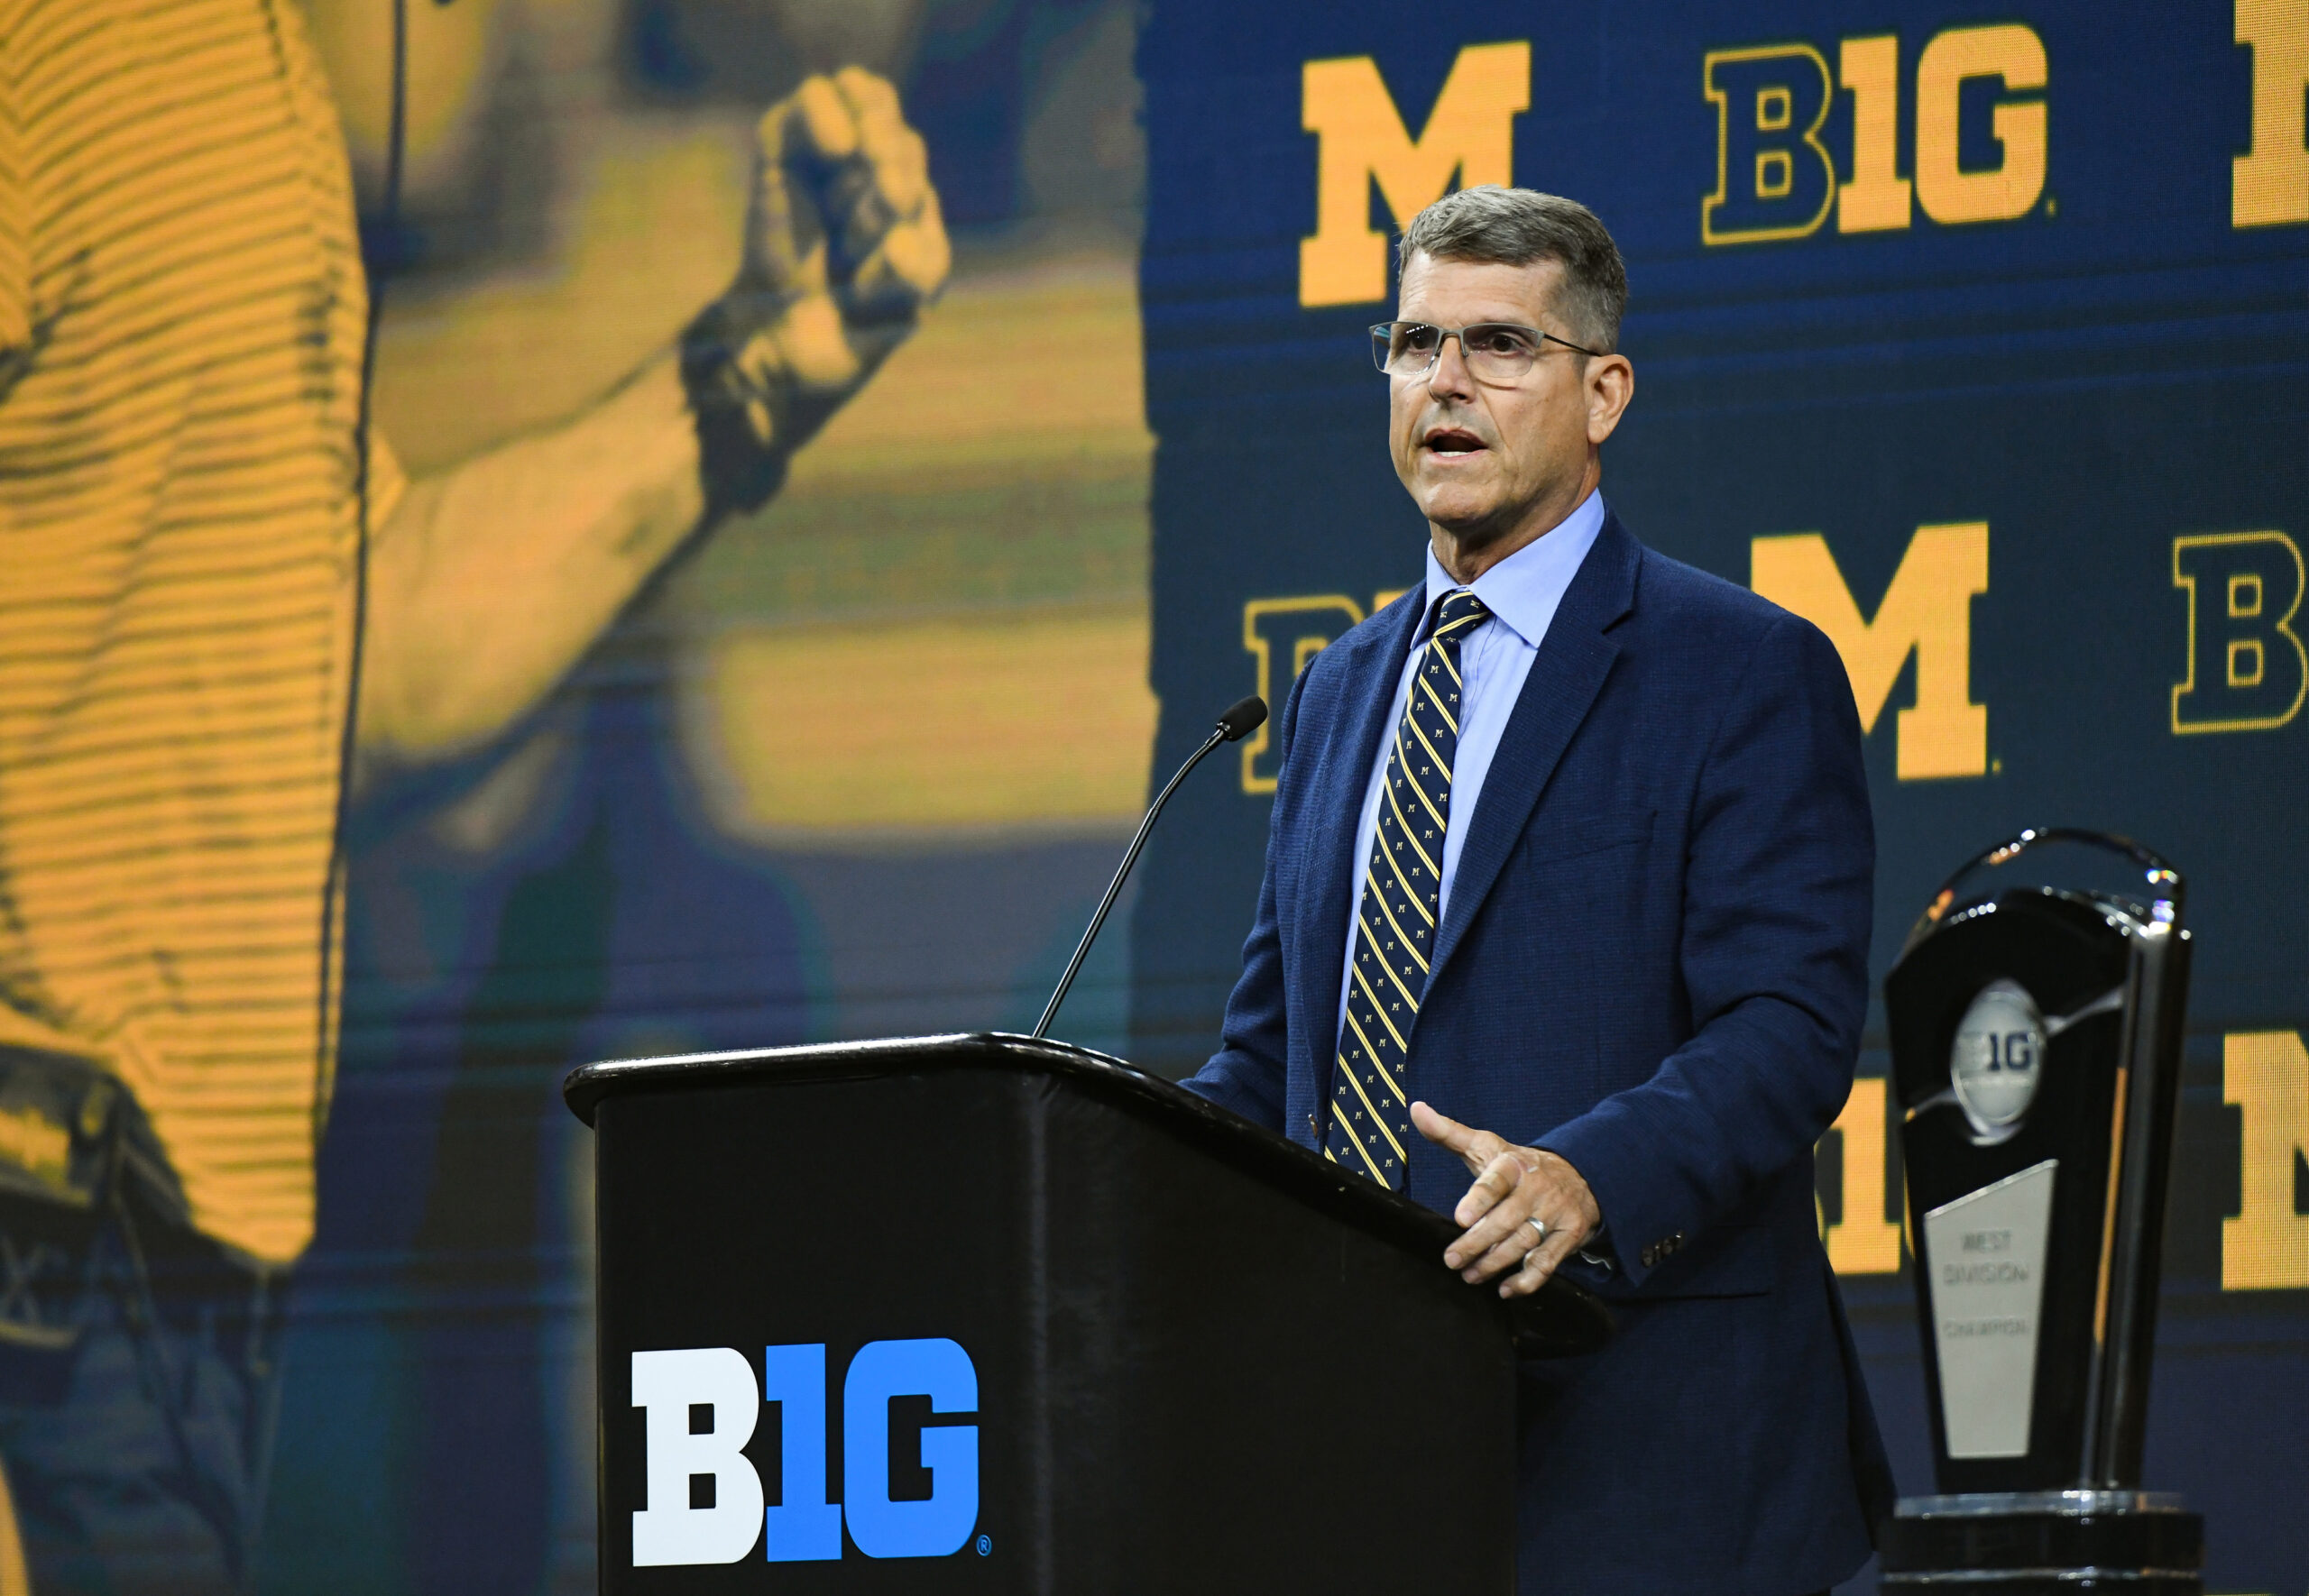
xmin=684 ymin=67 xmax=952 ymax=501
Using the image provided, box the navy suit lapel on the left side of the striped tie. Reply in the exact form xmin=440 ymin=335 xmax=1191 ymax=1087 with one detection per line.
xmin=1298 ymin=582 xmax=1427 ymax=1080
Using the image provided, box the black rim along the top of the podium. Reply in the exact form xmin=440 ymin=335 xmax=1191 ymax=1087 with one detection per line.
xmin=561 ymin=1030 xmax=1612 ymax=1358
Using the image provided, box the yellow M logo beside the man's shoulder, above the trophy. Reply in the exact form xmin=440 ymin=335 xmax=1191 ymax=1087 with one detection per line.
xmin=1748 ymin=522 xmax=1988 ymax=781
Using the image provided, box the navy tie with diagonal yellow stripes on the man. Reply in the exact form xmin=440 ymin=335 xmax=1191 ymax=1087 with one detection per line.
xmin=1323 ymin=587 xmax=1492 ymax=1189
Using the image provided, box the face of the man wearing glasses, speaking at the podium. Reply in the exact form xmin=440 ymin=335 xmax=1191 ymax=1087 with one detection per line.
xmin=1388 ymin=252 xmax=1616 ymax=543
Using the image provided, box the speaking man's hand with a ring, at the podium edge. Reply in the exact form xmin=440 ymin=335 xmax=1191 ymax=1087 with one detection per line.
xmin=1411 ymin=1102 xmax=1603 ymax=1296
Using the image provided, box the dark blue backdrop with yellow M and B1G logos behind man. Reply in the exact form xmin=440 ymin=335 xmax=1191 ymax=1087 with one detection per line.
xmin=1131 ymin=0 xmax=2309 ymax=1591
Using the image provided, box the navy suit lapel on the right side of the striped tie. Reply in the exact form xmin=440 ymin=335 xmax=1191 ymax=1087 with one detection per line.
xmin=1421 ymin=515 xmax=1642 ymax=991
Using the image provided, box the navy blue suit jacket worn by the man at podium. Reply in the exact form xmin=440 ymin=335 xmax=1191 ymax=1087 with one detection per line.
xmin=1187 ymin=518 xmax=1891 ymax=1596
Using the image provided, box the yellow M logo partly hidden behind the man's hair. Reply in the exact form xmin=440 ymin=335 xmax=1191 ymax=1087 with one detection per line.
xmin=1300 ymin=40 xmax=1531 ymax=305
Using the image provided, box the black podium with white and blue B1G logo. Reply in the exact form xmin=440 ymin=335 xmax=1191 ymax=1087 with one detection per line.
xmin=564 ymin=1035 xmax=1609 ymax=1593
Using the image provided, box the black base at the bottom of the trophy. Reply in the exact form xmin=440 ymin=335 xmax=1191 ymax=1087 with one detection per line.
xmin=1877 ymin=1490 xmax=2205 ymax=1596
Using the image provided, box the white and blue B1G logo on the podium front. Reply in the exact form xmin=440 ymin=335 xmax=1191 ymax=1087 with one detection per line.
xmin=632 ymin=1337 xmax=979 ymax=1568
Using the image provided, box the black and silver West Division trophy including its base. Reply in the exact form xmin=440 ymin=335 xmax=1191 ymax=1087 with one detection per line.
xmin=1881 ymin=830 xmax=2203 ymax=1596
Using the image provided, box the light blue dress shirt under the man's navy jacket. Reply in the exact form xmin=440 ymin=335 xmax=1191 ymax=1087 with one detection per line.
xmin=1337 ymin=490 xmax=1603 ymax=1053
